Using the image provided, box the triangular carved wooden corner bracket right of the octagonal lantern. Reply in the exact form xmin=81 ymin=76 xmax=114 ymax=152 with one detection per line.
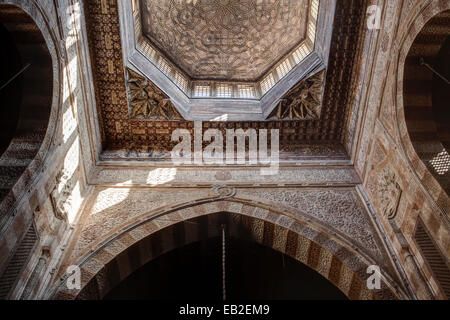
xmin=267 ymin=70 xmax=325 ymax=120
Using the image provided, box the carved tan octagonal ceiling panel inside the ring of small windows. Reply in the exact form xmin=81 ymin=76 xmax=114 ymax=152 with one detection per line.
xmin=140 ymin=0 xmax=310 ymax=81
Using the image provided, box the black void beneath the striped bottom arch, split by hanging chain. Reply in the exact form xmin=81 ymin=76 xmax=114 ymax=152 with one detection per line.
xmin=105 ymin=237 xmax=347 ymax=301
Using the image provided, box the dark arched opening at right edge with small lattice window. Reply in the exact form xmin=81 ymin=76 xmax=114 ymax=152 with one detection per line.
xmin=404 ymin=10 xmax=450 ymax=195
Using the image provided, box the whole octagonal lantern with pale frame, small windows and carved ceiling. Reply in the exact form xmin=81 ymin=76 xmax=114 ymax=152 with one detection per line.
xmin=123 ymin=0 xmax=330 ymax=116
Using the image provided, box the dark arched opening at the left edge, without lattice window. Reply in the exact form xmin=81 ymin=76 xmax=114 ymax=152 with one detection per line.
xmin=0 ymin=4 xmax=53 ymax=205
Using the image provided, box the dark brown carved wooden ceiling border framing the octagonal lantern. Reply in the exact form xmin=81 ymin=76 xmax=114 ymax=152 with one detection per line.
xmin=85 ymin=0 xmax=366 ymax=159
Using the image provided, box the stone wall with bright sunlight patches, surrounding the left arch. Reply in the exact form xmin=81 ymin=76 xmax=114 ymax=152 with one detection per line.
xmin=0 ymin=0 xmax=96 ymax=299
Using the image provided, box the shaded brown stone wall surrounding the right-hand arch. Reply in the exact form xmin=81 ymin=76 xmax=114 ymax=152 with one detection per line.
xmin=347 ymin=0 xmax=450 ymax=299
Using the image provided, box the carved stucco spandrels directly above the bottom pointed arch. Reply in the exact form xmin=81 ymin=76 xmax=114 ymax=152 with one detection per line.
xmin=67 ymin=188 xmax=381 ymax=261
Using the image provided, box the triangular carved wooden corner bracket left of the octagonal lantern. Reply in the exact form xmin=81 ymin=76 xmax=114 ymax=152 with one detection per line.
xmin=127 ymin=69 xmax=184 ymax=121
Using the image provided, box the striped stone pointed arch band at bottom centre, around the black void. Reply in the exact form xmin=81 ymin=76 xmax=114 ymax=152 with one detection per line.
xmin=50 ymin=199 xmax=398 ymax=299
